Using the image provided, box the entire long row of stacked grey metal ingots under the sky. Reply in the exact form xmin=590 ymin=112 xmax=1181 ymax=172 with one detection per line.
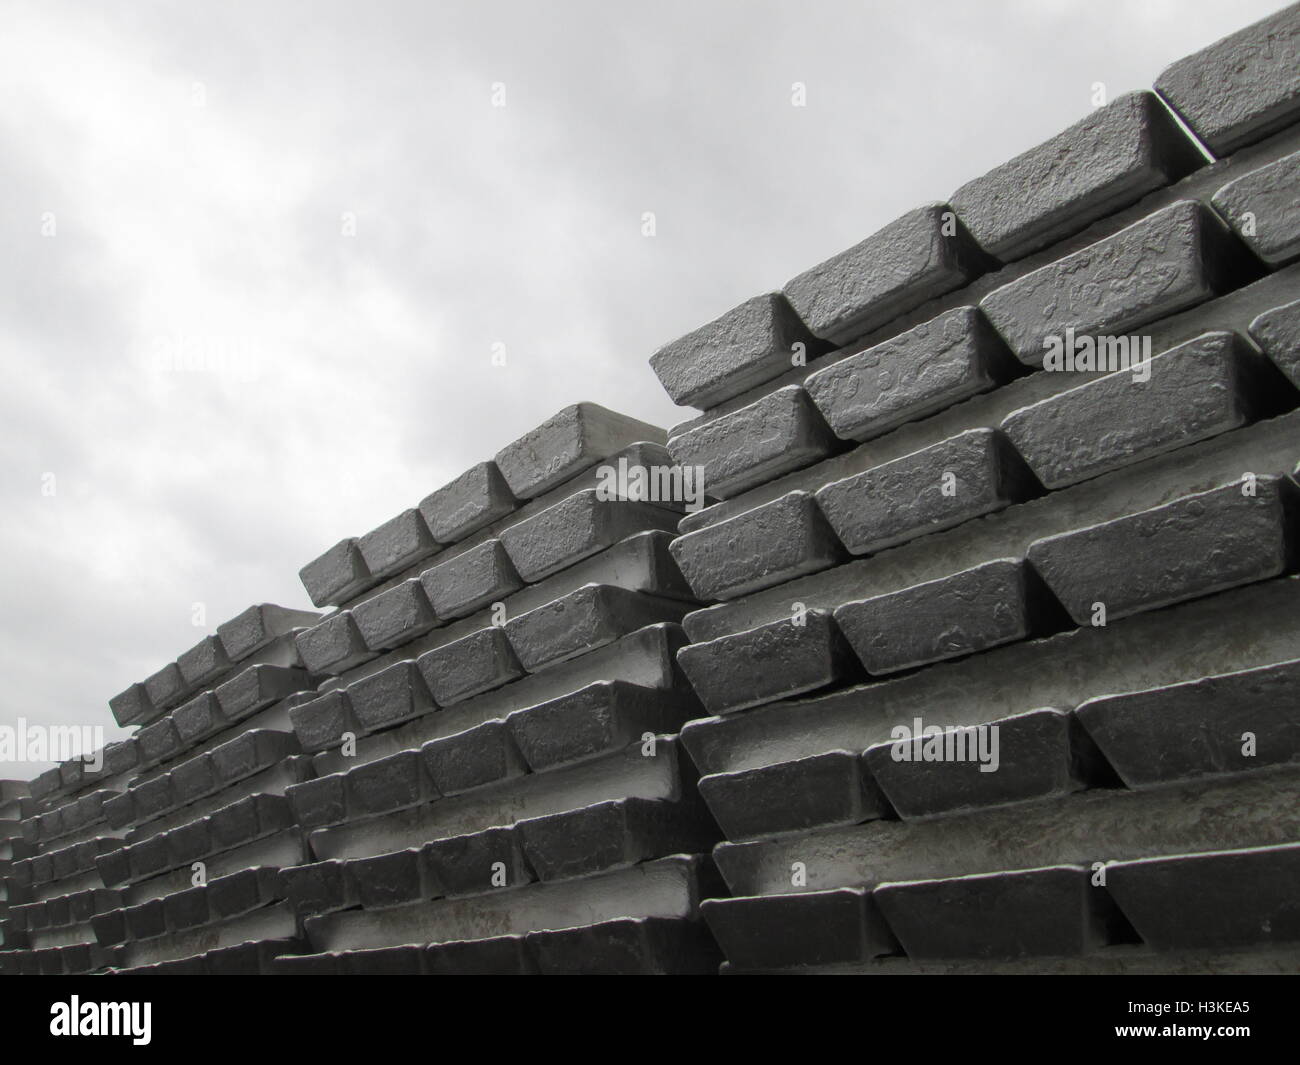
xmin=0 ymin=7 xmax=1300 ymax=974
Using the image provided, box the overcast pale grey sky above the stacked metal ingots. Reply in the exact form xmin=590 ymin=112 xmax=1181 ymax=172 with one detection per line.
xmin=0 ymin=0 xmax=1279 ymax=778
